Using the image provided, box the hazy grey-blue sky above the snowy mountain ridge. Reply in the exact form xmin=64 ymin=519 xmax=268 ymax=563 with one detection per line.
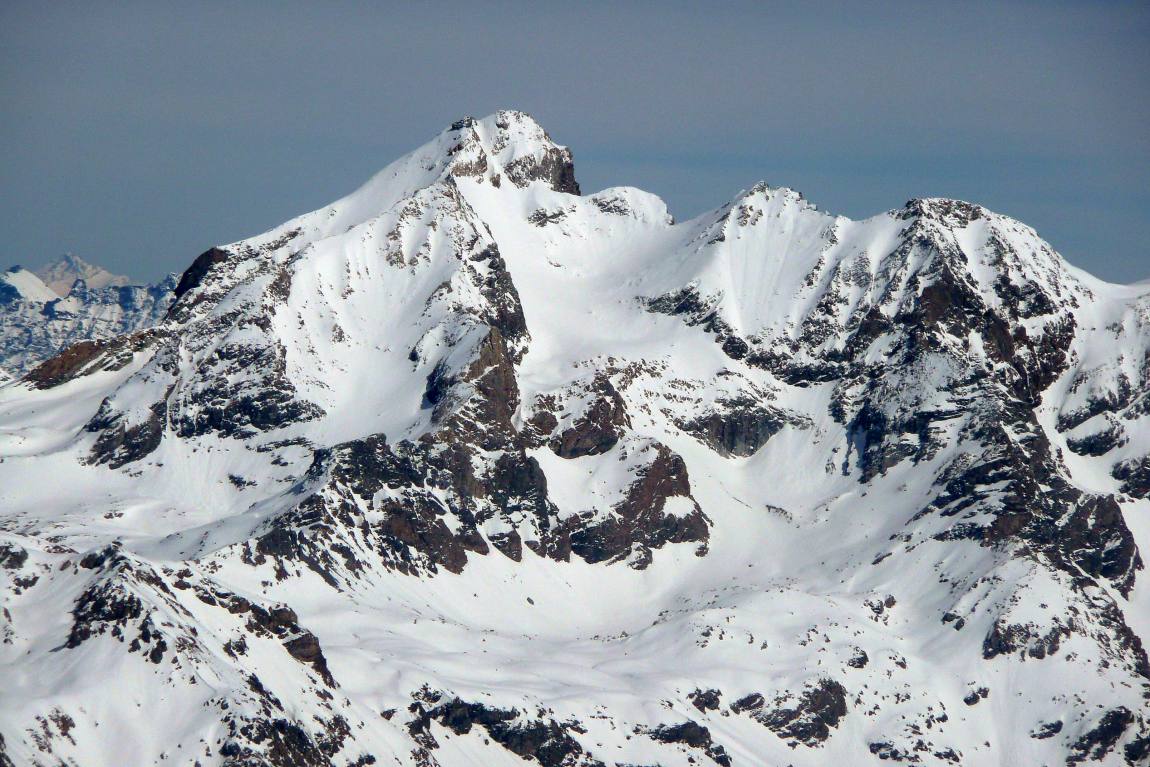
xmin=0 ymin=0 xmax=1150 ymax=282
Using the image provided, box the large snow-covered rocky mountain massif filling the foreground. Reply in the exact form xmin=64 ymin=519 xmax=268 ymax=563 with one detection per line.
xmin=0 ymin=112 xmax=1150 ymax=767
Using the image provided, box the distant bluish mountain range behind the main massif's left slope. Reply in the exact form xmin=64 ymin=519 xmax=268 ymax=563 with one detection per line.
xmin=0 ymin=264 xmax=177 ymax=375
